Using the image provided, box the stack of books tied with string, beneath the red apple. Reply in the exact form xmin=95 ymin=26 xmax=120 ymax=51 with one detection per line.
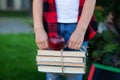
xmin=36 ymin=50 xmax=86 ymax=74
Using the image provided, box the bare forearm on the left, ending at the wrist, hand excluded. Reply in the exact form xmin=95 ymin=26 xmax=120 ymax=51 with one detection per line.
xmin=33 ymin=0 xmax=44 ymax=32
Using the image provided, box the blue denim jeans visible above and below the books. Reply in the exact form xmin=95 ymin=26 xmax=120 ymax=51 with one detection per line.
xmin=46 ymin=23 xmax=88 ymax=80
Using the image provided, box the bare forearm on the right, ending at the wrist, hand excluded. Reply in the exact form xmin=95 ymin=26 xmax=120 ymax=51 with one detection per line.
xmin=76 ymin=0 xmax=96 ymax=33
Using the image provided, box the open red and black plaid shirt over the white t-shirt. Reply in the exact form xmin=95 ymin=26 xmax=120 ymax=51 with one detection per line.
xmin=43 ymin=0 xmax=97 ymax=40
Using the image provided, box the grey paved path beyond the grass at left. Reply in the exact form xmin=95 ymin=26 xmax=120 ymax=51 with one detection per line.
xmin=0 ymin=18 xmax=33 ymax=34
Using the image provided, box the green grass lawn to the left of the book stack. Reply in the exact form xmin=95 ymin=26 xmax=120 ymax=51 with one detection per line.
xmin=0 ymin=34 xmax=45 ymax=80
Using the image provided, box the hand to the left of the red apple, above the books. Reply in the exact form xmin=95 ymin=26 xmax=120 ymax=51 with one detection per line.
xmin=35 ymin=29 xmax=48 ymax=49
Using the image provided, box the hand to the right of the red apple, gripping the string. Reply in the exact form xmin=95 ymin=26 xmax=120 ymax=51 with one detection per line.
xmin=68 ymin=30 xmax=84 ymax=50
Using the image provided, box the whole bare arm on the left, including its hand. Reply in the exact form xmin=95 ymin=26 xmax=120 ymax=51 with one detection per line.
xmin=33 ymin=0 xmax=48 ymax=49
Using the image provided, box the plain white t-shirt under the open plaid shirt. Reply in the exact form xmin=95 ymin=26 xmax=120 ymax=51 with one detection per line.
xmin=56 ymin=0 xmax=79 ymax=23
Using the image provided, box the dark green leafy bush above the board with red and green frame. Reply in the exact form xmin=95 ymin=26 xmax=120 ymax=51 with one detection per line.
xmin=89 ymin=31 xmax=120 ymax=68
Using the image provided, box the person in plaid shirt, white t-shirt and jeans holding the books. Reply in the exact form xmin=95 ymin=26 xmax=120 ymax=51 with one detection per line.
xmin=33 ymin=0 xmax=97 ymax=80
